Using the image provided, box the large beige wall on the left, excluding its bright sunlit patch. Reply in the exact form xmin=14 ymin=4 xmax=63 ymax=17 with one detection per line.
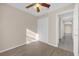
xmin=0 ymin=4 xmax=37 ymax=51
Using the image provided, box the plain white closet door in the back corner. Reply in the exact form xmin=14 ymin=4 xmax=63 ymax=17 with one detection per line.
xmin=38 ymin=17 xmax=48 ymax=43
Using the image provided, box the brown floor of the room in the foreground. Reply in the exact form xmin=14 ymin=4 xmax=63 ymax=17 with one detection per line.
xmin=0 ymin=41 xmax=73 ymax=56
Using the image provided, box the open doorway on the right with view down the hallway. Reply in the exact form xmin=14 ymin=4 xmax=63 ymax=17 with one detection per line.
xmin=58 ymin=12 xmax=73 ymax=52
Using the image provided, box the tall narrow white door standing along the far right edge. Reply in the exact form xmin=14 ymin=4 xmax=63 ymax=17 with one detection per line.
xmin=73 ymin=4 xmax=78 ymax=56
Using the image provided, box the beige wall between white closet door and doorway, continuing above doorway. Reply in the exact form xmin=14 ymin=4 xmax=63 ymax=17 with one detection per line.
xmin=39 ymin=4 xmax=74 ymax=45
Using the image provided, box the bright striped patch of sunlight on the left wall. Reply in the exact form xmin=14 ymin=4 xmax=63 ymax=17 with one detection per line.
xmin=26 ymin=29 xmax=39 ymax=44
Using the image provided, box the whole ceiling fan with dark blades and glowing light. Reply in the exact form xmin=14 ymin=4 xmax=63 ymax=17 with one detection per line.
xmin=26 ymin=3 xmax=50 ymax=12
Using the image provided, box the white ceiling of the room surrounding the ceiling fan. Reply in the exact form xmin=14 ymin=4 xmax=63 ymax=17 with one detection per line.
xmin=9 ymin=3 xmax=69 ymax=16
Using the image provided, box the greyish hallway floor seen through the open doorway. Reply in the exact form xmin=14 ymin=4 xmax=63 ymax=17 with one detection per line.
xmin=59 ymin=34 xmax=73 ymax=52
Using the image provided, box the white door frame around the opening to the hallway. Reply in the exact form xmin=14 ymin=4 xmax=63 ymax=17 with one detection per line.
xmin=56 ymin=4 xmax=79 ymax=56
